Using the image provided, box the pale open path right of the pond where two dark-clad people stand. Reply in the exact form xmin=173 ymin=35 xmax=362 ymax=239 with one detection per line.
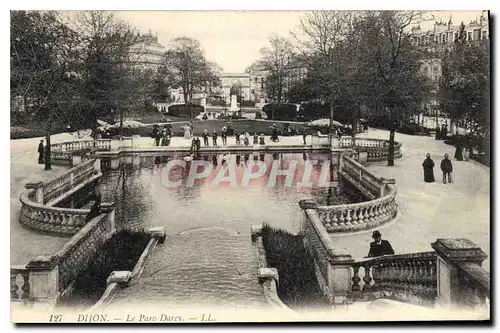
xmin=332 ymin=129 xmax=490 ymax=271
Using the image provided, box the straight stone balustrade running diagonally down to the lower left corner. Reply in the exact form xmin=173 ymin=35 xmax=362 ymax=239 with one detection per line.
xmin=10 ymin=203 xmax=116 ymax=306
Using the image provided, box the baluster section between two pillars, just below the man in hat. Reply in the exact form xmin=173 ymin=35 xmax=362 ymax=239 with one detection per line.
xmin=351 ymin=251 xmax=437 ymax=306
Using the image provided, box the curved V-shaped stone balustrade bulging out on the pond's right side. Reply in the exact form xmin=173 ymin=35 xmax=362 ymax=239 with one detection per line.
xmin=310 ymin=156 xmax=397 ymax=233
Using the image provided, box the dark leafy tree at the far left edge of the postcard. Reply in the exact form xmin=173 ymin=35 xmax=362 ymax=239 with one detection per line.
xmin=11 ymin=11 xmax=79 ymax=170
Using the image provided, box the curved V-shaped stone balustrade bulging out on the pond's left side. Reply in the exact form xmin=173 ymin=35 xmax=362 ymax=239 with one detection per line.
xmin=19 ymin=160 xmax=101 ymax=236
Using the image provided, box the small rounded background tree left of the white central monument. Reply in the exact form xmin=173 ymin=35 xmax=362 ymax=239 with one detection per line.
xmin=162 ymin=37 xmax=220 ymax=119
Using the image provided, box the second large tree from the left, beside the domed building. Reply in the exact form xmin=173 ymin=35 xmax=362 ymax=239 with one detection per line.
xmin=68 ymin=11 xmax=138 ymax=134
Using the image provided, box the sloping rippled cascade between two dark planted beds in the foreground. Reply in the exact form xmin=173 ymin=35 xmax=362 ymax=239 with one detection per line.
xmin=109 ymin=228 xmax=266 ymax=309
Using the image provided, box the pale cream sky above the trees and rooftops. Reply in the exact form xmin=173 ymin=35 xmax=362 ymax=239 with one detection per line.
xmin=118 ymin=11 xmax=481 ymax=73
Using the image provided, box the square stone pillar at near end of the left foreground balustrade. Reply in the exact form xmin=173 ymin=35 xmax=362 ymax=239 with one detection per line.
xmin=26 ymin=255 xmax=59 ymax=306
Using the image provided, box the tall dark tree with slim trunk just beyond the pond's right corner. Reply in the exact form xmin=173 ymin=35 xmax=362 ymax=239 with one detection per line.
xmin=346 ymin=11 xmax=430 ymax=166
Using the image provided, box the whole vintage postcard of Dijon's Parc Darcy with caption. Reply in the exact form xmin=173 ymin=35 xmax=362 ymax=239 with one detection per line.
xmin=10 ymin=10 xmax=491 ymax=324
